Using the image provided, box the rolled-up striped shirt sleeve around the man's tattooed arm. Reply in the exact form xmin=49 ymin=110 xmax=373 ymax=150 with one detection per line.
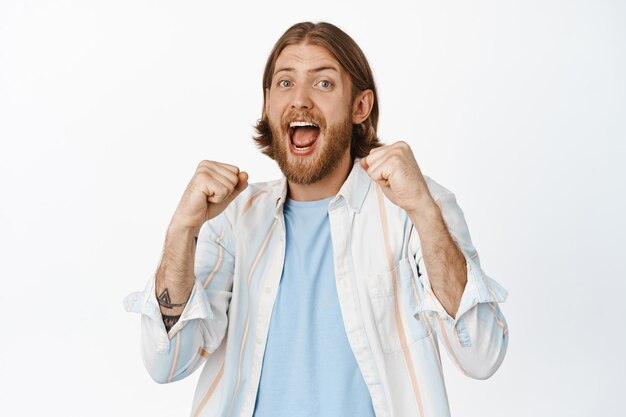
xmin=124 ymin=215 xmax=235 ymax=383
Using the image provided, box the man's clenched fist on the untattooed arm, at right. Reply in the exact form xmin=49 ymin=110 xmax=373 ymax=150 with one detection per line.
xmin=360 ymin=141 xmax=434 ymax=213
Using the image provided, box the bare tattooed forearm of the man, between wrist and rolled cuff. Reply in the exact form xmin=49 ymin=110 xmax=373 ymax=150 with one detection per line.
xmin=155 ymin=222 xmax=197 ymax=331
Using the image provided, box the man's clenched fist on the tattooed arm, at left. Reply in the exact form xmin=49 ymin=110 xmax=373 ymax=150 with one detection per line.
xmin=172 ymin=160 xmax=248 ymax=229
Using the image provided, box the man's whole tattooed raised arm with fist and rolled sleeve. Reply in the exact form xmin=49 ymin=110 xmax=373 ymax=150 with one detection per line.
xmin=125 ymin=161 xmax=247 ymax=383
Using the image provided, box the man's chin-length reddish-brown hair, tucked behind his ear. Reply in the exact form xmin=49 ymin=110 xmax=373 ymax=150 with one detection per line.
xmin=253 ymin=22 xmax=382 ymax=159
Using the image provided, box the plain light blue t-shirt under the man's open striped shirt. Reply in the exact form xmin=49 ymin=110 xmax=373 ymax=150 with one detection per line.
xmin=254 ymin=197 xmax=375 ymax=417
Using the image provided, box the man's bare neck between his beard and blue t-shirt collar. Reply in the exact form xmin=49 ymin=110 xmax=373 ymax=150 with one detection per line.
xmin=288 ymin=152 xmax=352 ymax=201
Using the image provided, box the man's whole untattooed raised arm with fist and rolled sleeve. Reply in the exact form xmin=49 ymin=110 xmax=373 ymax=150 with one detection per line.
xmin=361 ymin=142 xmax=508 ymax=379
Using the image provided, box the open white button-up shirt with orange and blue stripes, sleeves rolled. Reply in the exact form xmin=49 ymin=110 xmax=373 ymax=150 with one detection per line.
xmin=124 ymin=160 xmax=508 ymax=417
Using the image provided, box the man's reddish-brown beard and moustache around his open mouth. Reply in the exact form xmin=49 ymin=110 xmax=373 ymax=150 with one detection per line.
xmin=270 ymin=108 xmax=352 ymax=185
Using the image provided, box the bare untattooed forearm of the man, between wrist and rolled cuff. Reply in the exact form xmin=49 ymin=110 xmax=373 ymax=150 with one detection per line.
xmin=408 ymin=195 xmax=467 ymax=317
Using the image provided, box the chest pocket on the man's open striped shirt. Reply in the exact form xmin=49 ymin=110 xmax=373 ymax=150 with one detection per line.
xmin=367 ymin=258 xmax=430 ymax=353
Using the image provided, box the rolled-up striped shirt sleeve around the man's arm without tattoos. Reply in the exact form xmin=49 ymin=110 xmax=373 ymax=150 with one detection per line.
xmin=411 ymin=179 xmax=508 ymax=379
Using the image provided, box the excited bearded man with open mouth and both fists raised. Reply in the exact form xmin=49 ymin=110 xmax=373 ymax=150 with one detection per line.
xmin=126 ymin=23 xmax=508 ymax=417
